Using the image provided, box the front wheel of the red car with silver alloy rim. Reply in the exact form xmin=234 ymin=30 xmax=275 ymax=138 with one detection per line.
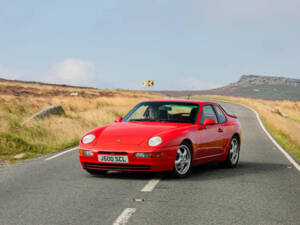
xmin=173 ymin=142 xmax=193 ymax=178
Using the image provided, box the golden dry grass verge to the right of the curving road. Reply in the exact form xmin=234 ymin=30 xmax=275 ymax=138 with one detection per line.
xmin=198 ymin=95 xmax=300 ymax=159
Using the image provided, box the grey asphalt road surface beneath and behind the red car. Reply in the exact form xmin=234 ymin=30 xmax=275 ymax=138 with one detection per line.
xmin=0 ymin=103 xmax=300 ymax=225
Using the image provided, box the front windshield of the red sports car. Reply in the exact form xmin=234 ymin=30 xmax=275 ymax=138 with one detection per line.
xmin=122 ymin=102 xmax=199 ymax=123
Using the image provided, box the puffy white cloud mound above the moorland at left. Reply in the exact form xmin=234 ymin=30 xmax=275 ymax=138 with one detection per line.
xmin=46 ymin=58 xmax=97 ymax=86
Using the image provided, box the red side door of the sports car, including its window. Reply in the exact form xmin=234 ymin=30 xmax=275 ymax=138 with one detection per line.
xmin=196 ymin=104 xmax=223 ymax=159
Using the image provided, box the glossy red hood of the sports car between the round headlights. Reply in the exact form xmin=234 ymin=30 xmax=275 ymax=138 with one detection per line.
xmin=96 ymin=122 xmax=184 ymax=147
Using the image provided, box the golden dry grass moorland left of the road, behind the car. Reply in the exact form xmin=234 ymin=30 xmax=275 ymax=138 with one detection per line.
xmin=0 ymin=82 xmax=161 ymax=162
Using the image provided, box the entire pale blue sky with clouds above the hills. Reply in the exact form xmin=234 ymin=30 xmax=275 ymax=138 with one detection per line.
xmin=0 ymin=0 xmax=300 ymax=90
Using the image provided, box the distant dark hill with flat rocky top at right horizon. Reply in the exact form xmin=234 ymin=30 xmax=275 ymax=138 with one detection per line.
xmin=159 ymin=75 xmax=300 ymax=101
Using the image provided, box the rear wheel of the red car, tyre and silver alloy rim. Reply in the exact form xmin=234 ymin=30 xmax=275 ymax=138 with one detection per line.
xmin=223 ymin=136 xmax=240 ymax=168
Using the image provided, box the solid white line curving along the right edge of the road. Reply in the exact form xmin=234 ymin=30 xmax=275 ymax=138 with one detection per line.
xmin=218 ymin=100 xmax=300 ymax=172
